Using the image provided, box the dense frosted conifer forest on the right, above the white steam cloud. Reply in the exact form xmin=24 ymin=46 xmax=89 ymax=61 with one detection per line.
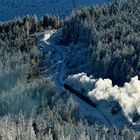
xmin=63 ymin=0 xmax=140 ymax=85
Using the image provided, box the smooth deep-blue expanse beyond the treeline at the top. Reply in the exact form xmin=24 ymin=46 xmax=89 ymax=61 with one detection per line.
xmin=0 ymin=0 xmax=115 ymax=21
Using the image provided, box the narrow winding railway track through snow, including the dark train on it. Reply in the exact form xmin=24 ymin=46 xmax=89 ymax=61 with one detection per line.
xmin=37 ymin=32 xmax=113 ymax=127
